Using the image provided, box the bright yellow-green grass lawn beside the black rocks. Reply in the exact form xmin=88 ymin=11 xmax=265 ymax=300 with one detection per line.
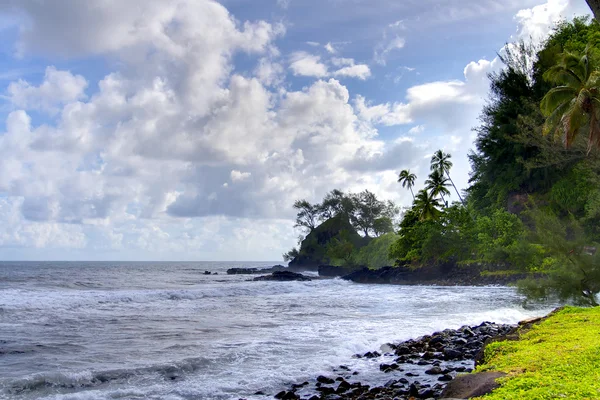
xmin=477 ymin=307 xmax=600 ymax=400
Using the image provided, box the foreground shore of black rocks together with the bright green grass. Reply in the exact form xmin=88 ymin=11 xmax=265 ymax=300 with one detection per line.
xmin=264 ymin=307 xmax=600 ymax=400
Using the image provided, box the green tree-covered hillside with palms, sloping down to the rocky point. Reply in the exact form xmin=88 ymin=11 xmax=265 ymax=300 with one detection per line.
xmin=287 ymin=18 xmax=600 ymax=305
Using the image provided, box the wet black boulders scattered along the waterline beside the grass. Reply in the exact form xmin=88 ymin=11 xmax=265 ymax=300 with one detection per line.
xmin=268 ymin=322 xmax=516 ymax=400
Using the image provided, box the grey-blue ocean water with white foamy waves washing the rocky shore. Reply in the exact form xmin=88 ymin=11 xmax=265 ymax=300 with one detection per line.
xmin=0 ymin=262 xmax=549 ymax=400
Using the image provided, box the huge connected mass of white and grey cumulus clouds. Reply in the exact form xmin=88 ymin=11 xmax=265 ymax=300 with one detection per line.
xmin=0 ymin=0 xmax=592 ymax=258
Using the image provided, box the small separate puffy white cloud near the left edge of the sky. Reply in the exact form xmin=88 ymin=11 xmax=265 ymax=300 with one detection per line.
xmin=7 ymin=67 xmax=88 ymax=113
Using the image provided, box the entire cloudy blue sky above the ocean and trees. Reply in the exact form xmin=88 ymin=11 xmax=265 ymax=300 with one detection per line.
xmin=0 ymin=0 xmax=589 ymax=261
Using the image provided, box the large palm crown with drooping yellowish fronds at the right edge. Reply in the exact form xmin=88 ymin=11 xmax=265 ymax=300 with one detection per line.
xmin=540 ymin=47 xmax=600 ymax=152
